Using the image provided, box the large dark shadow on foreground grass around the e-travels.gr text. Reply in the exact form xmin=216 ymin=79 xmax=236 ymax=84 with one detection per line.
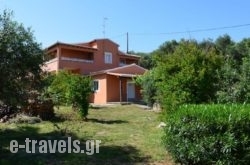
xmin=0 ymin=126 xmax=150 ymax=165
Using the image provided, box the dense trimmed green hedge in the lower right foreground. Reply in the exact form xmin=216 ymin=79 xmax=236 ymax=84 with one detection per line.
xmin=164 ymin=104 xmax=250 ymax=164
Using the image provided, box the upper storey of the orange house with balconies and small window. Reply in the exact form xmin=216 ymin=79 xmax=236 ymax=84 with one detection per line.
xmin=43 ymin=39 xmax=140 ymax=75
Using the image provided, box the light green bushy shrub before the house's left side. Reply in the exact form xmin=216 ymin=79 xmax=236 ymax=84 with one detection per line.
xmin=48 ymin=71 xmax=91 ymax=118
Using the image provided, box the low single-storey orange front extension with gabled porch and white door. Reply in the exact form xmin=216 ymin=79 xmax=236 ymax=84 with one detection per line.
xmin=90 ymin=64 xmax=146 ymax=104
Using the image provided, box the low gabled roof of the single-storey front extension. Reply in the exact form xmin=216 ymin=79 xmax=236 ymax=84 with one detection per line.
xmin=90 ymin=64 xmax=147 ymax=77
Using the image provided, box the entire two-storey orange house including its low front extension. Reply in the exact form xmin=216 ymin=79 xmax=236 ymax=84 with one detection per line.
xmin=43 ymin=39 xmax=145 ymax=104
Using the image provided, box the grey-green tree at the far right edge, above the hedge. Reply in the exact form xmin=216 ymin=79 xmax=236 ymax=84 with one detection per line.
xmin=216 ymin=39 xmax=250 ymax=103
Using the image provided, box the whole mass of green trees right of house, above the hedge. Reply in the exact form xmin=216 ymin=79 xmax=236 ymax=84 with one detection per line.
xmin=137 ymin=35 xmax=250 ymax=110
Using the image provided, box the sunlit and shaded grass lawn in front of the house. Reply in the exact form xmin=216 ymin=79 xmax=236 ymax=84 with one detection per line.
xmin=0 ymin=105 xmax=172 ymax=165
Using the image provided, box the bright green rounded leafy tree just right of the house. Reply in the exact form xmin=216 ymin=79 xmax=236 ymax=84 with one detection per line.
xmin=154 ymin=40 xmax=221 ymax=110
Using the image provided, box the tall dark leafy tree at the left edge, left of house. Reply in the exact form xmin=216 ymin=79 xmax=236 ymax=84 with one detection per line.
xmin=0 ymin=10 xmax=44 ymax=107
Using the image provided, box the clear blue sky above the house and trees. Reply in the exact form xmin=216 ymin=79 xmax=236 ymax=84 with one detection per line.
xmin=0 ymin=0 xmax=250 ymax=53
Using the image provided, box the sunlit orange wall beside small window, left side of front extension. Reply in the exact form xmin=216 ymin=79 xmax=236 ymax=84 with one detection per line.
xmin=90 ymin=74 xmax=107 ymax=104
